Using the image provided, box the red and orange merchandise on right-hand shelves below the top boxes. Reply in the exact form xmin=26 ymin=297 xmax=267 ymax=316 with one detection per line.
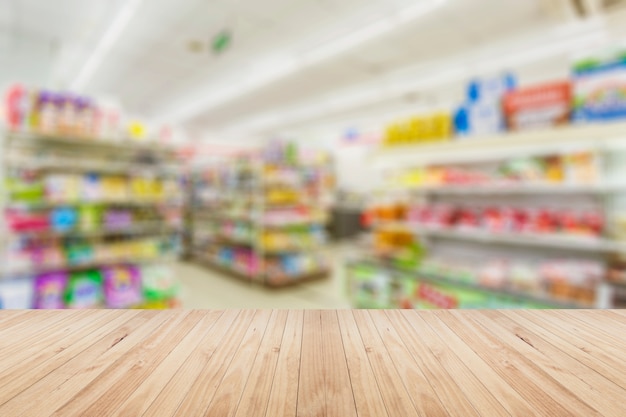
xmin=348 ymin=138 xmax=626 ymax=308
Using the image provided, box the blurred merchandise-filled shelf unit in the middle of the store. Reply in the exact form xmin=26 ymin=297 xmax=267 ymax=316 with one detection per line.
xmin=192 ymin=144 xmax=332 ymax=286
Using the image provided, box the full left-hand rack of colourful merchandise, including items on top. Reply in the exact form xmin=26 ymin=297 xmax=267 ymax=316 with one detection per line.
xmin=0 ymin=87 xmax=182 ymax=308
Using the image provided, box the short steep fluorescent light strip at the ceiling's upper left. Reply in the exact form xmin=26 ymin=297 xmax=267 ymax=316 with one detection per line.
xmin=71 ymin=0 xmax=142 ymax=91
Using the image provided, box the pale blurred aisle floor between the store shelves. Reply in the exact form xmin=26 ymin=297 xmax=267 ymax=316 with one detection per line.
xmin=174 ymin=248 xmax=350 ymax=309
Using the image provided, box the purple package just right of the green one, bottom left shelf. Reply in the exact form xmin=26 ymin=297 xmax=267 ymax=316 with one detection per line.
xmin=102 ymin=265 xmax=142 ymax=308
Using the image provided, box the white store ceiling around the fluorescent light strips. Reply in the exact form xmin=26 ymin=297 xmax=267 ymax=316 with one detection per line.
xmin=0 ymin=0 xmax=624 ymax=141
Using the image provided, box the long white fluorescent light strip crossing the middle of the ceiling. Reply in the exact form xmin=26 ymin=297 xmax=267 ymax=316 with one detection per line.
xmin=161 ymin=0 xmax=447 ymax=123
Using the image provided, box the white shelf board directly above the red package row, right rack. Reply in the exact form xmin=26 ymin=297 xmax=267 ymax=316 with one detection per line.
xmin=407 ymin=184 xmax=626 ymax=195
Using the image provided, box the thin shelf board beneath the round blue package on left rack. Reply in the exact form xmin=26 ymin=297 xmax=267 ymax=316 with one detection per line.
xmin=9 ymin=222 xmax=181 ymax=238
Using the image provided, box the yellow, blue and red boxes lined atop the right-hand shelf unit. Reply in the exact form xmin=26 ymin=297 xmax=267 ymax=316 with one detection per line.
xmin=383 ymin=49 xmax=626 ymax=146
